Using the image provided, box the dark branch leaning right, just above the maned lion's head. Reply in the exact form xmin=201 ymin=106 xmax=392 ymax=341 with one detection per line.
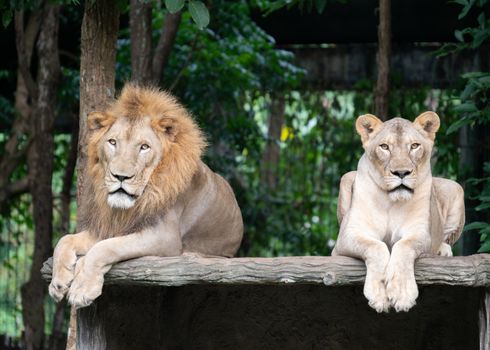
xmin=152 ymin=11 xmax=182 ymax=85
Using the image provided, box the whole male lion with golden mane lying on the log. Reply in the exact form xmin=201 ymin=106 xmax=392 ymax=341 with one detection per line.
xmin=49 ymin=85 xmax=243 ymax=307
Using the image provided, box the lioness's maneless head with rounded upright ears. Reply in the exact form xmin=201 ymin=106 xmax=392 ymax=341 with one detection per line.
xmin=356 ymin=112 xmax=439 ymax=201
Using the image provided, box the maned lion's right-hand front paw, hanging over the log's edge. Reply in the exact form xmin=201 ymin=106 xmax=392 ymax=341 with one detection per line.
xmin=68 ymin=258 xmax=104 ymax=308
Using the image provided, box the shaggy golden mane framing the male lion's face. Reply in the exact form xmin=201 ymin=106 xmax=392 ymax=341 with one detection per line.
xmin=81 ymin=84 xmax=206 ymax=239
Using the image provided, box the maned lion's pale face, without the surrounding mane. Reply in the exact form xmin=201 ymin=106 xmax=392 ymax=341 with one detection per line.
xmin=99 ymin=118 xmax=162 ymax=209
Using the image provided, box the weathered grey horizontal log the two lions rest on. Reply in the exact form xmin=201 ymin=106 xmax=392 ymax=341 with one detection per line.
xmin=41 ymin=254 xmax=490 ymax=287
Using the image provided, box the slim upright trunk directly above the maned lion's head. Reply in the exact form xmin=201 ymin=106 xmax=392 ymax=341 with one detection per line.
xmin=129 ymin=0 xmax=152 ymax=84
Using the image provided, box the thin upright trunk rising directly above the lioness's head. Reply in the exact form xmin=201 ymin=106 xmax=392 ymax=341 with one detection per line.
xmin=375 ymin=0 xmax=391 ymax=120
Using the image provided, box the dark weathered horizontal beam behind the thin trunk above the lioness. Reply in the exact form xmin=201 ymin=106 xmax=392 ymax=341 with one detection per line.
xmin=285 ymin=44 xmax=490 ymax=90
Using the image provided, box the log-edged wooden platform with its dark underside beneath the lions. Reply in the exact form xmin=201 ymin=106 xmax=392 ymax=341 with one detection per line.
xmin=42 ymin=254 xmax=490 ymax=350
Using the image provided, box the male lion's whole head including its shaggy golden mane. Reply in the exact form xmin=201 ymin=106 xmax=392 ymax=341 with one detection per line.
xmin=87 ymin=85 xmax=205 ymax=213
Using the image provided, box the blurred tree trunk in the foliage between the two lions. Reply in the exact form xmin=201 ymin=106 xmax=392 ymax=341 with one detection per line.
xmin=260 ymin=94 xmax=285 ymax=190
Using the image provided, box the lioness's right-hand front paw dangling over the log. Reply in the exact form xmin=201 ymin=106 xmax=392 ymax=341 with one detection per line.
xmin=386 ymin=268 xmax=419 ymax=312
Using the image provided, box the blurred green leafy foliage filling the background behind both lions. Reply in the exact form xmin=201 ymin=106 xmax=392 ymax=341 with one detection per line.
xmin=0 ymin=0 xmax=490 ymax=344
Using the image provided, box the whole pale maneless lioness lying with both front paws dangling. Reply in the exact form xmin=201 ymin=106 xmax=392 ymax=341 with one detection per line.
xmin=332 ymin=112 xmax=464 ymax=312
